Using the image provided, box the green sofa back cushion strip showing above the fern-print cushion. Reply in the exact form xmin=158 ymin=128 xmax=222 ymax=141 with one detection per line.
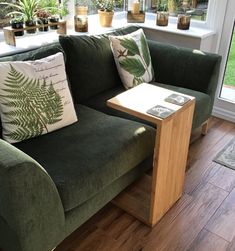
xmin=0 ymin=42 xmax=63 ymax=138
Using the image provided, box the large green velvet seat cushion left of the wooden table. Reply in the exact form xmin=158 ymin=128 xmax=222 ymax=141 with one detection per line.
xmin=15 ymin=105 xmax=155 ymax=211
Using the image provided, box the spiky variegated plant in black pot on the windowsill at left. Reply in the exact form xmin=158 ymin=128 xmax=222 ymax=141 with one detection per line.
xmin=1 ymin=0 xmax=39 ymax=33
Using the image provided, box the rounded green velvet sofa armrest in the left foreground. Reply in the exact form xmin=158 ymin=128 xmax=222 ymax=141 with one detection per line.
xmin=0 ymin=140 xmax=65 ymax=251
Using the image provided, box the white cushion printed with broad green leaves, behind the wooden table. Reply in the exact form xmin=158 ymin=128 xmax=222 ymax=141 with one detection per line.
xmin=109 ymin=29 xmax=154 ymax=89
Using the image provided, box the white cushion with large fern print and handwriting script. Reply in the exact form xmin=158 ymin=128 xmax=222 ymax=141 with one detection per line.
xmin=0 ymin=52 xmax=77 ymax=143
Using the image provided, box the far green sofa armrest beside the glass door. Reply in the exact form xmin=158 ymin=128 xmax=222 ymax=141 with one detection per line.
xmin=148 ymin=40 xmax=221 ymax=99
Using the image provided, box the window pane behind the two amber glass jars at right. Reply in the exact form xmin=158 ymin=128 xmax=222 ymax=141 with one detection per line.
xmin=150 ymin=0 xmax=209 ymax=21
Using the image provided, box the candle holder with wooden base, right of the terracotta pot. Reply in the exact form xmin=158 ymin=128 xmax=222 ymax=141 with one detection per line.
xmin=127 ymin=0 xmax=145 ymax=23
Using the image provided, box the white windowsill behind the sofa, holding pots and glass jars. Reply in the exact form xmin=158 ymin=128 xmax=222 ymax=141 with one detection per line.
xmin=0 ymin=12 xmax=215 ymax=56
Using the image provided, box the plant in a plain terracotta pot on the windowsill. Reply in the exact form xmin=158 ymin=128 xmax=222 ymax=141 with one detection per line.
xmin=98 ymin=0 xmax=114 ymax=27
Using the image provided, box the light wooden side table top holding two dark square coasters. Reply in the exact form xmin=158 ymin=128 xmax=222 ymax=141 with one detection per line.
xmin=107 ymin=83 xmax=195 ymax=124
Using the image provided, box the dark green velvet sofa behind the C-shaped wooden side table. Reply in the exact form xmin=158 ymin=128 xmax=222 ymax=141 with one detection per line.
xmin=0 ymin=26 xmax=221 ymax=251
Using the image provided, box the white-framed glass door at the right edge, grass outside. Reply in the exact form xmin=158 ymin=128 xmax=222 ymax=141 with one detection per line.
xmin=213 ymin=0 xmax=235 ymax=122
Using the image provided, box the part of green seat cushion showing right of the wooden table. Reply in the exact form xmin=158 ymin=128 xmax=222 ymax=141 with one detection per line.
xmin=151 ymin=82 xmax=211 ymax=130
